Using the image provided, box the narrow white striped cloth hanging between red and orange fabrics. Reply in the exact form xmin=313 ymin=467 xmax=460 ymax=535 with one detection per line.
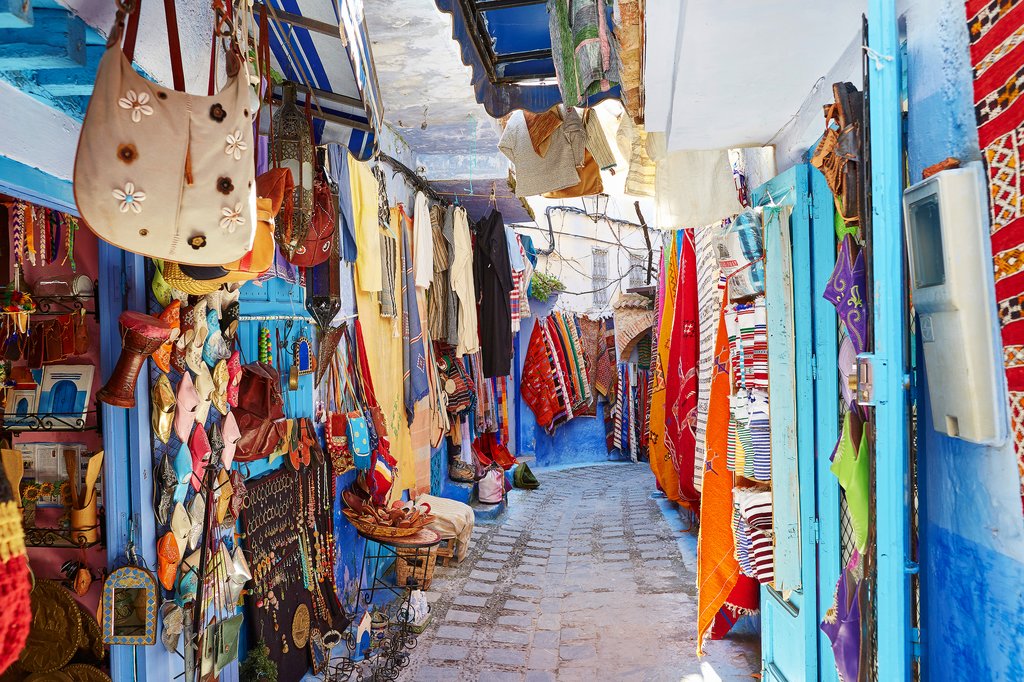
xmin=693 ymin=220 xmax=724 ymax=493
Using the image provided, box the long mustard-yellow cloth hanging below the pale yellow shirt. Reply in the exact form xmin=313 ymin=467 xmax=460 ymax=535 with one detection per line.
xmin=355 ymin=206 xmax=416 ymax=499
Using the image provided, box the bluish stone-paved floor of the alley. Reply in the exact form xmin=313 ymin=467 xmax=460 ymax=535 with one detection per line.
xmin=399 ymin=464 xmax=760 ymax=682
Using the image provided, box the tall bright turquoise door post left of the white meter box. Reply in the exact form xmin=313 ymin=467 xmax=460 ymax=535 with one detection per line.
xmin=867 ymin=0 xmax=918 ymax=682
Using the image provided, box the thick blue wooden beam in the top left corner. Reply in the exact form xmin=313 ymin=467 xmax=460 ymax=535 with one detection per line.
xmin=0 ymin=9 xmax=85 ymax=72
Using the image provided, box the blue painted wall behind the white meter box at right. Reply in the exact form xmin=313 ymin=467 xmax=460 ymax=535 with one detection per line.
xmin=905 ymin=0 xmax=1024 ymax=680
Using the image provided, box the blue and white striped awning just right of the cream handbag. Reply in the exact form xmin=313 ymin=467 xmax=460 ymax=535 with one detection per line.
xmin=254 ymin=0 xmax=382 ymax=161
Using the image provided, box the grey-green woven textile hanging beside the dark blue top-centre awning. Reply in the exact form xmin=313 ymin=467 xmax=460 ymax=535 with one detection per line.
xmin=548 ymin=0 xmax=618 ymax=106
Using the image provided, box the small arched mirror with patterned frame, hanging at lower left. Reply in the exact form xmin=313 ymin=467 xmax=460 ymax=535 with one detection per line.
xmin=102 ymin=566 xmax=157 ymax=645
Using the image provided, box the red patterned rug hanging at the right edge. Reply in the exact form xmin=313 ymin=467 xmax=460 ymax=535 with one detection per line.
xmin=967 ymin=0 xmax=1024 ymax=505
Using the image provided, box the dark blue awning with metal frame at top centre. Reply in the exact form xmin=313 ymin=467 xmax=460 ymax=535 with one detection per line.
xmin=434 ymin=0 xmax=618 ymax=118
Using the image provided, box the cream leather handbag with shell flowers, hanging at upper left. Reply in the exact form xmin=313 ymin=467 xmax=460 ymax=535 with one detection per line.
xmin=75 ymin=0 xmax=256 ymax=265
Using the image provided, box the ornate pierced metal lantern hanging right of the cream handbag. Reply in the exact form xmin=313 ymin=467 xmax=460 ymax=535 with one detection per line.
xmin=270 ymin=81 xmax=313 ymax=256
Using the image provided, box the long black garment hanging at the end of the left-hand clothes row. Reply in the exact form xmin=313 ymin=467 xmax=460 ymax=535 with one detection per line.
xmin=473 ymin=210 xmax=512 ymax=378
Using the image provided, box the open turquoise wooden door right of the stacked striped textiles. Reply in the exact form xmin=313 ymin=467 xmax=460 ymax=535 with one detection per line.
xmin=754 ymin=165 xmax=840 ymax=682
